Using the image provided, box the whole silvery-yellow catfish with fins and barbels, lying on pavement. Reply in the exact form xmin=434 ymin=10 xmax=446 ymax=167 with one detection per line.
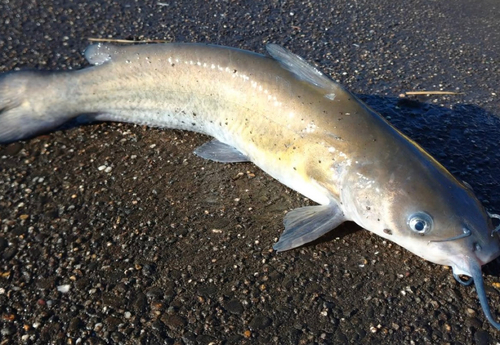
xmin=0 ymin=43 xmax=500 ymax=328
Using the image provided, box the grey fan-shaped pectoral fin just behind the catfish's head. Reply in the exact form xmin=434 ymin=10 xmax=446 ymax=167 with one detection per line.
xmin=273 ymin=204 xmax=346 ymax=252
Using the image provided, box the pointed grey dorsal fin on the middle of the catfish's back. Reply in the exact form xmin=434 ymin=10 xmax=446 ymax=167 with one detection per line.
xmin=266 ymin=43 xmax=343 ymax=97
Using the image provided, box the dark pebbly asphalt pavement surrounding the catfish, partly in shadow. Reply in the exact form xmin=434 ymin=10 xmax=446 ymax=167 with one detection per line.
xmin=0 ymin=0 xmax=500 ymax=345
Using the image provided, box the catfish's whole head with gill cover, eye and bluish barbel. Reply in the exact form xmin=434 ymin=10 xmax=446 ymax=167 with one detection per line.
xmin=341 ymin=142 xmax=500 ymax=330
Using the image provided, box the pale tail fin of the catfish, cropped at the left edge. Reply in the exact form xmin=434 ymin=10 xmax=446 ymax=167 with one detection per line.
xmin=0 ymin=72 xmax=72 ymax=144
